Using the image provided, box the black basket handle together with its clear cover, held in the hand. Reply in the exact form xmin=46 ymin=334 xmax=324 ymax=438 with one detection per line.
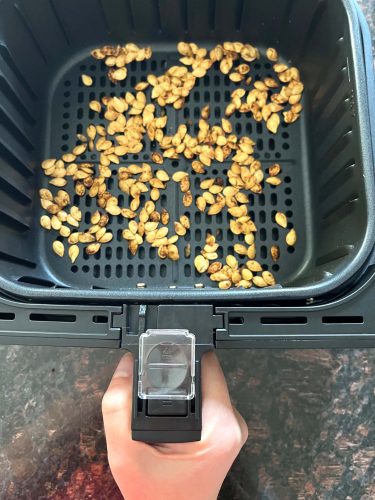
xmin=132 ymin=329 xmax=202 ymax=443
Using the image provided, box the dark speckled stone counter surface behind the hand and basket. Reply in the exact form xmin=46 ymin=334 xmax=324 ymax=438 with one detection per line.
xmin=0 ymin=0 xmax=375 ymax=500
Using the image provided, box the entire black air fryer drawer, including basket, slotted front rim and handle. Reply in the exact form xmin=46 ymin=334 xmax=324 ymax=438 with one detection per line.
xmin=0 ymin=0 xmax=375 ymax=440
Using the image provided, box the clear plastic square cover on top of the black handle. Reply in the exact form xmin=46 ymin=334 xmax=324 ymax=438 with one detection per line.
xmin=138 ymin=330 xmax=195 ymax=400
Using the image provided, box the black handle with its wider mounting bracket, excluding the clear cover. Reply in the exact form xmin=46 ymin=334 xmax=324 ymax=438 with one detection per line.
xmin=122 ymin=305 xmax=217 ymax=443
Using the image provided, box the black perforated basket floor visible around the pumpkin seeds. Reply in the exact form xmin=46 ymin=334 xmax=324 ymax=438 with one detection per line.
xmin=36 ymin=48 xmax=309 ymax=288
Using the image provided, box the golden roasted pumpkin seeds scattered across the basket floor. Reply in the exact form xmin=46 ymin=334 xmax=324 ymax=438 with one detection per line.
xmin=40 ymin=42 xmax=304 ymax=289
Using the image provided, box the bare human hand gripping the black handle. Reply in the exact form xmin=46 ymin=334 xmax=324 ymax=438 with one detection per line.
xmin=102 ymin=352 xmax=248 ymax=500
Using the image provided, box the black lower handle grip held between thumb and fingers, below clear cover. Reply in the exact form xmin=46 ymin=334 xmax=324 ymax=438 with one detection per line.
xmin=132 ymin=358 xmax=202 ymax=443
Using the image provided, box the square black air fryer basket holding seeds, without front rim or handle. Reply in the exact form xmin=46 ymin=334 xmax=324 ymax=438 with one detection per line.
xmin=0 ymin=0 xmax=374 ymax=301
